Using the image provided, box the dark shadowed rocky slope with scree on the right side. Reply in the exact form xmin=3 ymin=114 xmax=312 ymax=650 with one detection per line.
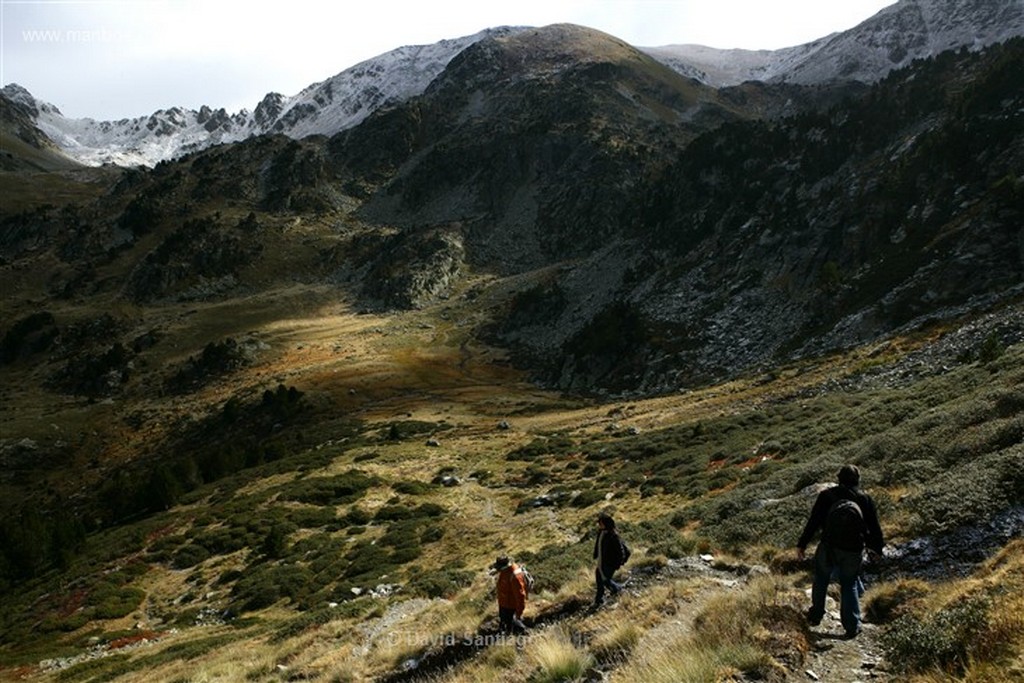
xmin=520 ymin=39 xmax=1024 ymax=390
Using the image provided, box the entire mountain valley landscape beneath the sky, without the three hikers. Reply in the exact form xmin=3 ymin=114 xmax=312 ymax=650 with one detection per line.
xmin=0 ymin=0 xmax=1024 ymax=683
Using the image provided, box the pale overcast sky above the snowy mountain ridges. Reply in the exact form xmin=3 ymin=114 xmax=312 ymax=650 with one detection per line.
xmin=0 ymin=0 xmax=894 ymax=120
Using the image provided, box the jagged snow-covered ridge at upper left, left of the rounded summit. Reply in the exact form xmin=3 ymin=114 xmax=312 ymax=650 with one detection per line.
xmin=2 ymin=27 xmax=518 ymax=166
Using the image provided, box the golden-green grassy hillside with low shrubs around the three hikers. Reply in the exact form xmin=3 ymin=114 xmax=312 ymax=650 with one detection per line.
xmin=0 ymin=280 xmax=1024 ymax=681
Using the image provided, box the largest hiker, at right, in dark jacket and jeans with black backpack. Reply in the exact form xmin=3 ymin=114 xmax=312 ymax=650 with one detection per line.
xmin=797 ymin=465 xmax=885 ymax=638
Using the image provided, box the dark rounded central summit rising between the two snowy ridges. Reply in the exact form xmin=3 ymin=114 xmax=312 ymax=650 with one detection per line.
xmin=331 ymin=26 xmax=740 ymax=272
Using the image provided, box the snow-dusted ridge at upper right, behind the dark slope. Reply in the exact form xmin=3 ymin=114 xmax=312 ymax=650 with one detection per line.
xmin=644 ymin=0 xmax=1024 ymax=87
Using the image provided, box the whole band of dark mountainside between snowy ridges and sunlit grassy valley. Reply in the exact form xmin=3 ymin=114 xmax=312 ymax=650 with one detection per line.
xmin=0 ymin=26 xmax=1024 ymax=393
